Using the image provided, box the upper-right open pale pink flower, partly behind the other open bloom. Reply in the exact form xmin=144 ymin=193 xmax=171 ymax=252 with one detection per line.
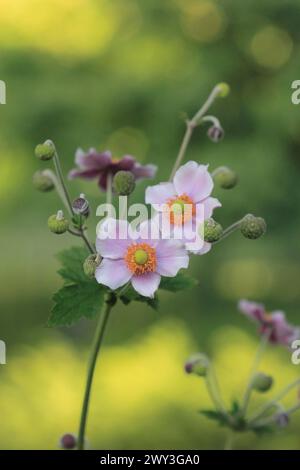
xmin=146 ymin=161 xmax=221 ymax=254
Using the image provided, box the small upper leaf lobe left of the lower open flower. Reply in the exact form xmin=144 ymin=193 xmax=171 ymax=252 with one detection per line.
xmin=57 ymin=246 xmax=89 ymax=282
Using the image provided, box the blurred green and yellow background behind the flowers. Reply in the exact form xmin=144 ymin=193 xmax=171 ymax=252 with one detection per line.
xmin=0 ymin=0 xmax=300 ymax=449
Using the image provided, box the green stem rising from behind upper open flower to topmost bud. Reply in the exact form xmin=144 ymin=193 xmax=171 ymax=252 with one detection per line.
xmin=170 ymin=85 xmax=220 ymax=181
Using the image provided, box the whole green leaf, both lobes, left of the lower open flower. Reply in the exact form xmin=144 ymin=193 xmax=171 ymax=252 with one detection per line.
xmin=48 ymin=247 xmax=107 ymax=326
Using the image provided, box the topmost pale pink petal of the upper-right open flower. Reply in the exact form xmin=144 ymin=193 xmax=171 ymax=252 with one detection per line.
xmin=174 ymin=161 xmax=214 ymax=202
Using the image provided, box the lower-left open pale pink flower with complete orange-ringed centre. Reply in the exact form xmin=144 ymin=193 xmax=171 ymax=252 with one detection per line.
xmin=95 ymin=219 xmax=189 ymax=297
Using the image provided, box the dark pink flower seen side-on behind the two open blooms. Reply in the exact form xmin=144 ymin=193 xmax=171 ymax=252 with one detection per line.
xmin=69 ymin=148 xmax=157 ymax=191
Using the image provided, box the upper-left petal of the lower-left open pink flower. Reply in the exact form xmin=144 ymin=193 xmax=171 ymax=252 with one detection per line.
xmin=96 ymin=219 xmax=134 ymax=259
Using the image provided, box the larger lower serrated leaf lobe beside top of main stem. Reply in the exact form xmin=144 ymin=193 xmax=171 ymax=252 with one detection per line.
xmin=48 ymin=280 xmax=106 ymax=326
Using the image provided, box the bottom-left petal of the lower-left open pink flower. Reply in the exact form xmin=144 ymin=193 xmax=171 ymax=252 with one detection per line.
xmin=95 ymin=258 xmax=132 ymax=290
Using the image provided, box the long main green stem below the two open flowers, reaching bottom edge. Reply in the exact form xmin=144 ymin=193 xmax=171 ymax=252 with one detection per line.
xmin=77 ymin=302 xmax=111 ymax=450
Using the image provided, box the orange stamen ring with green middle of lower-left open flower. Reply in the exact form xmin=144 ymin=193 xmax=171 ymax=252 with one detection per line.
xmin=124 ymin=243 xmax=156 ymax=276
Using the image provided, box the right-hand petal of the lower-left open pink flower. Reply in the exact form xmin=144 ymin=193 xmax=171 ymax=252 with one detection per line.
xmin=156 ymin=240 xmax=189 ymax=277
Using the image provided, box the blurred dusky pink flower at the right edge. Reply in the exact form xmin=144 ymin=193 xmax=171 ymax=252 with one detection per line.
xmin=238 ymin=300 xmax=300 ymax=346
